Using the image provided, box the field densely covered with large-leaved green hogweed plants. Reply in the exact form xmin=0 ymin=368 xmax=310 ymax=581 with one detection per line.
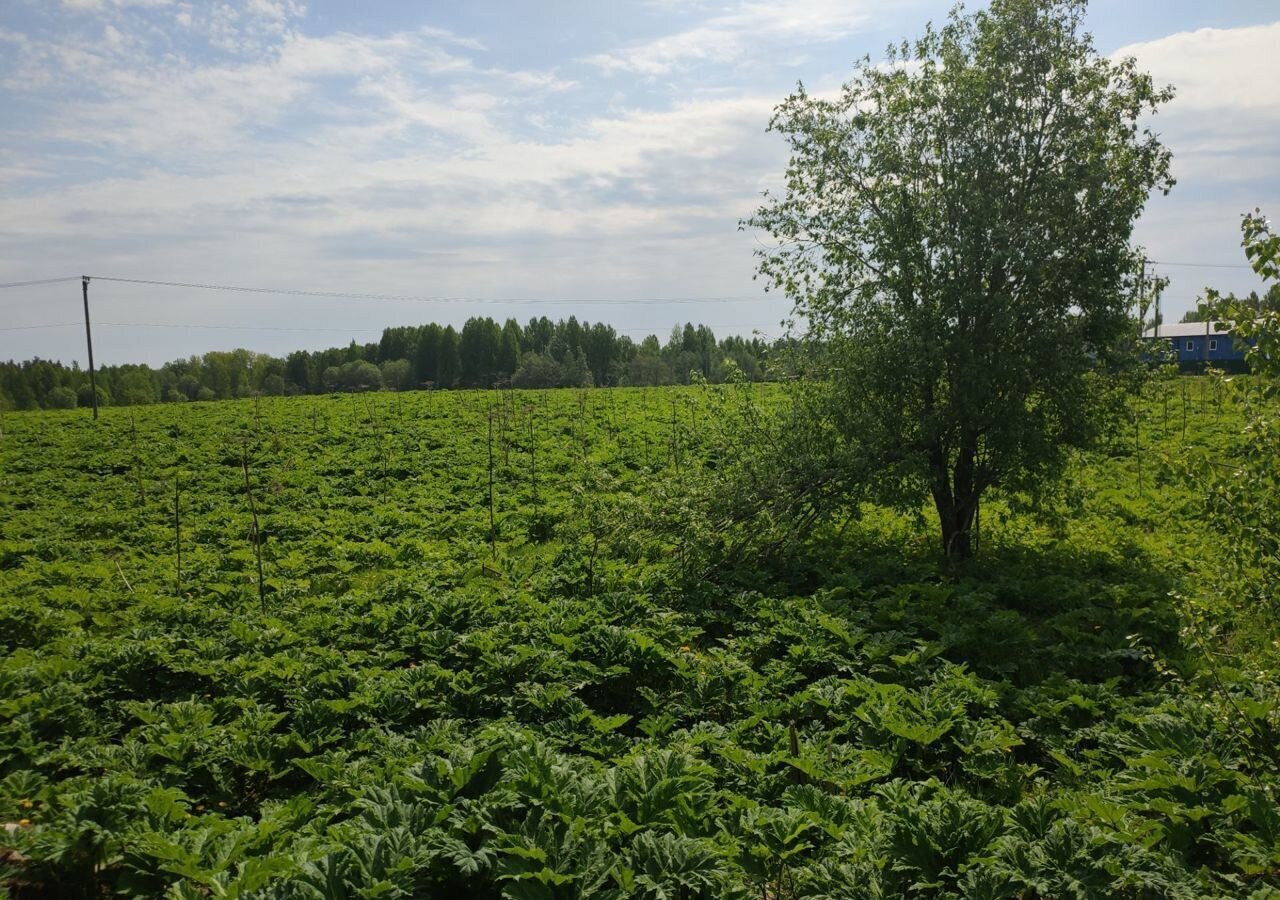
xmin=0 ymin=379 xmax=1280 ymax=900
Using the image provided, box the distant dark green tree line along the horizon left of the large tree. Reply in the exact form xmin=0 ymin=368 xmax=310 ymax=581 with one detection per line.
xmin=0 ymin=316 xmax=776 ymax=410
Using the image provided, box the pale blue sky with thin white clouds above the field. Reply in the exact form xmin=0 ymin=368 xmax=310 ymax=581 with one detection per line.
xmin=0 ymin=0 xmax=1280 ymax=365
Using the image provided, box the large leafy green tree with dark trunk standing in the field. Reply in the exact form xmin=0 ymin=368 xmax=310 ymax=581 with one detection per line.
xmin=744 ymin=0 xmax=1172 ymax=559
